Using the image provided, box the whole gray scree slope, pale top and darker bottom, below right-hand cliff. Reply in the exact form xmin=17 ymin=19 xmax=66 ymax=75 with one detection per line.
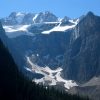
xmin=68 ymin=76 xmax=100 ymax=100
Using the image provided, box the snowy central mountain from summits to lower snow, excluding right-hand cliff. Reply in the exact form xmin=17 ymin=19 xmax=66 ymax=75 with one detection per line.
xmin=1 ymin=11 xmax=78 ymax=89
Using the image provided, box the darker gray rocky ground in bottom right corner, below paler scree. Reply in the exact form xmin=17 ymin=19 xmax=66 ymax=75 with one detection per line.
xmin=68 ymin=85 xmax=100 ymax=100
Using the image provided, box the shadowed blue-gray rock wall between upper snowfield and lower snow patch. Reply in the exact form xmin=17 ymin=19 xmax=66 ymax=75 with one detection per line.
xmin=12 ymin=31 xmax=70 ymax=69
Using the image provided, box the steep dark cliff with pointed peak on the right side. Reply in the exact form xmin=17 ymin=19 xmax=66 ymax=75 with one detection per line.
xmin=63 ymin=12 xmax=100 ymax=83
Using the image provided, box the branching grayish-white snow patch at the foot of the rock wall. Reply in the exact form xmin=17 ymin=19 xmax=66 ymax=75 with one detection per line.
xmin=25 ymin=55 xmax=78 ymax=89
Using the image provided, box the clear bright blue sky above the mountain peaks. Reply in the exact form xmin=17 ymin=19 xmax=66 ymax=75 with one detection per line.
xmin=0 ymin=0 xmax=100 ymax=19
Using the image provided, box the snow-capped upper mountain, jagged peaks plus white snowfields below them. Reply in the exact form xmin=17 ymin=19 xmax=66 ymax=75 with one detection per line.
xmin=1 ymin=11 xmax=79 ymax=38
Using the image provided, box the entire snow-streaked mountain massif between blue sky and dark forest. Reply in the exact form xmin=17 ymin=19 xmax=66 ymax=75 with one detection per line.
xmin=1 ymin=11 xmax=100 ymax=97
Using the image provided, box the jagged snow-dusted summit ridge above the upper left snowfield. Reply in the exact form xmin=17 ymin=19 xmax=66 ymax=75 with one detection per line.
xmin=1 ymin=11 xmax=58 ymax=25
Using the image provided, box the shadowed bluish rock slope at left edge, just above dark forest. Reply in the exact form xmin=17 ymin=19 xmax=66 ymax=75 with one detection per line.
xmin=0 ymin=22 xmax=25 ymax=69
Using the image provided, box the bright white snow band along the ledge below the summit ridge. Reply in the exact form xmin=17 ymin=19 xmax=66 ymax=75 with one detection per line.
xmin=3 ymin=19 xmax=78 ymax=38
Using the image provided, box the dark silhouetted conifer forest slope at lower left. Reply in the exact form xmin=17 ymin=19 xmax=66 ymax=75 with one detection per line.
xmin=0 ymin=40 xmax=89 ymax=100
